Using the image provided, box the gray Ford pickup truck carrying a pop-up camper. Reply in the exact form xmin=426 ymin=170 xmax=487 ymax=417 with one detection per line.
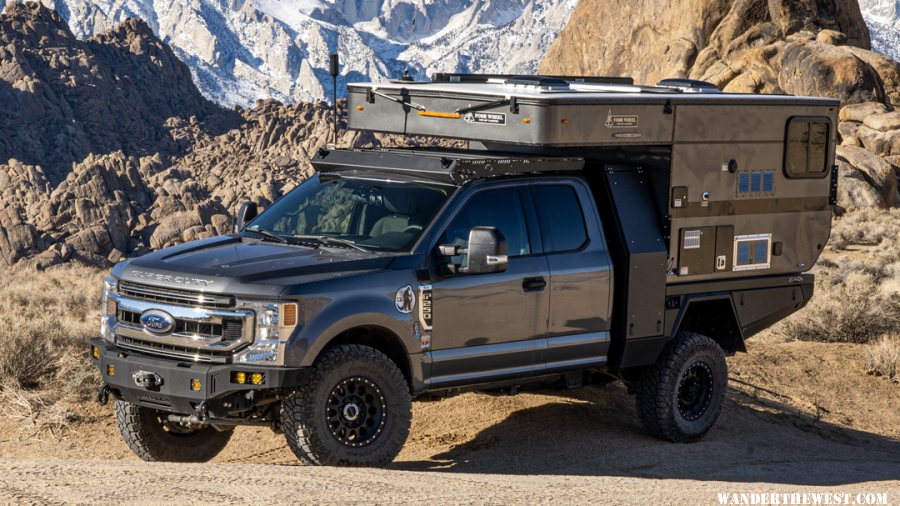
xmin=90 ymin=75 xmax=838 ymax=466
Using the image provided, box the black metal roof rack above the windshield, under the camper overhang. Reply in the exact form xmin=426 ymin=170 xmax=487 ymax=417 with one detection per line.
xmin=312 ymin=149 xmax=584 ymax=184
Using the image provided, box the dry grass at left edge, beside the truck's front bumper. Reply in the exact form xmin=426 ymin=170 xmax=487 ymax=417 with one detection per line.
xmin=0 ymin=266 xmax=102 ymax=435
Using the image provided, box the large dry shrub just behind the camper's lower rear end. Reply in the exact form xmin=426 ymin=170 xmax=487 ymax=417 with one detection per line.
xmin=777 ymin=268 xmax=900 ymax=343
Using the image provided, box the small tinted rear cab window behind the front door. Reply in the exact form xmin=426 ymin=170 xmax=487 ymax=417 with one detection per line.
xmin=531 ymin=185 xmax=587 ymax=253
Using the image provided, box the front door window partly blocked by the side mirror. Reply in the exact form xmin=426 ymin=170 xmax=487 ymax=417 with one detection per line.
xmin=441 ymin=189 xmax=531 ymax=264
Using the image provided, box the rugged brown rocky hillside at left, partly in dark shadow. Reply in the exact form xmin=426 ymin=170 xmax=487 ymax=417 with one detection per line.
xmin=0 ymin=4 xmax=426 ymax=268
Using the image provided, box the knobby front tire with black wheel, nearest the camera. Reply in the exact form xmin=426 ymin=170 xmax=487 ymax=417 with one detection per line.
xmin=281 ymin=344 xmax=412 ymax=467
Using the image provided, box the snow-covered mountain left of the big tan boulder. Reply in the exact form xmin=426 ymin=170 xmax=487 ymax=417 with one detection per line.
xmin=24 ymin=0 xmax=578 ymax=106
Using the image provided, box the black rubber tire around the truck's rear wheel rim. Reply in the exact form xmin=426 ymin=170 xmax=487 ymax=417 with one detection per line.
xmin=634 ymin=332 xmax=728 ymax=443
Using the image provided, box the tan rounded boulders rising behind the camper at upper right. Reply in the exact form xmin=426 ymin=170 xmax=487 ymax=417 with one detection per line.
xmin=540 ymin=0 xmax=900 ymax=209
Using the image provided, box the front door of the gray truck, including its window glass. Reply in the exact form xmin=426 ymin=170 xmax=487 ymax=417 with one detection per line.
xmin=431 ymin=186 xmax=550 ymax=386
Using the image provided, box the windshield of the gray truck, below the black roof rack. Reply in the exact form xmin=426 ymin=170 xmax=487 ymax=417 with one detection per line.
xmin=247 ymin=174 xmax=454 ymax=252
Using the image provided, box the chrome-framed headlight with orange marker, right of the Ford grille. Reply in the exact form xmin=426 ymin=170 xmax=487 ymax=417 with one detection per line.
xmin=237 ymin=301 xmax=297 ymax=365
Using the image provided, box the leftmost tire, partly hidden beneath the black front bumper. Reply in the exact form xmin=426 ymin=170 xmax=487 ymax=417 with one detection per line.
xmin=116 ymin=401 xmax=233 ymax=462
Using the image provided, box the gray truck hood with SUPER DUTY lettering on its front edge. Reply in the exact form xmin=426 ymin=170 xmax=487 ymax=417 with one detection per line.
xmin=113 ymin=236 xmax=394 ymax=296
